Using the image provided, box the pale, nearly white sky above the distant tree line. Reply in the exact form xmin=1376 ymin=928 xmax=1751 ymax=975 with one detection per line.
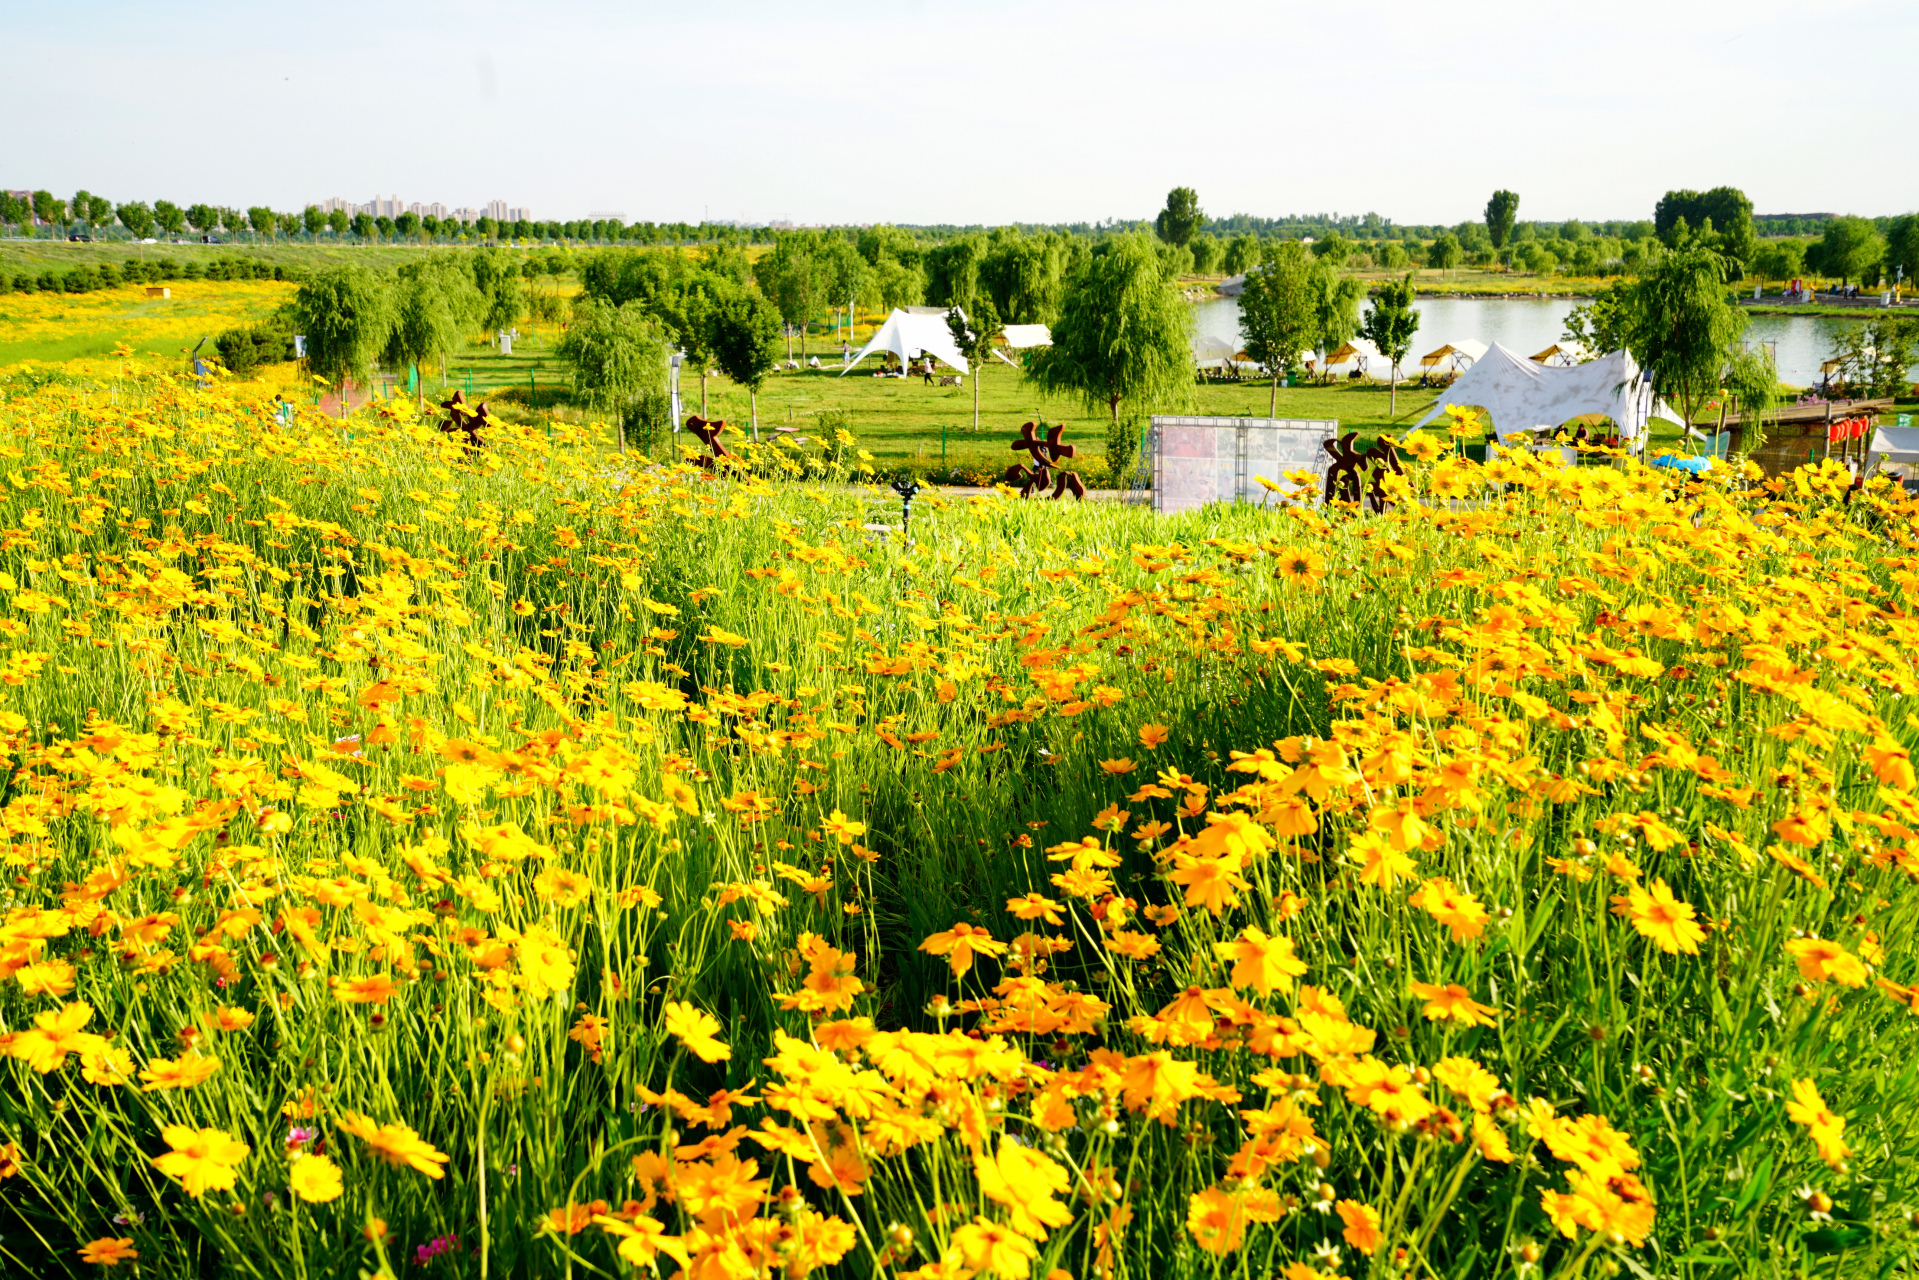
xmin=0 ymin=0 xmax=1919 ymax=223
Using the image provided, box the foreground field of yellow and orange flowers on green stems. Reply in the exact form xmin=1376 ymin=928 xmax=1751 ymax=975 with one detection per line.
xmin=0 ymin=360 xmax=1919 ymax=1280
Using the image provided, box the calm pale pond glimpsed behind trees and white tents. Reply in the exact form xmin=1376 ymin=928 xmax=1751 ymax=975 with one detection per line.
xmin=1194 ymin=297 xmax=1903 ymax=388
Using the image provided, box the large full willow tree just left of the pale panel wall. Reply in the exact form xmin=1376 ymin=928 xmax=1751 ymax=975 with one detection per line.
xmin=1027 ymin=234 xmax=1194 ymax=422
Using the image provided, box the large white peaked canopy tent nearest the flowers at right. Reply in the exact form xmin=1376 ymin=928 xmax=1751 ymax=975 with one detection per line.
xmin=1418 ymin=342 xmax=1679 ymax=439
